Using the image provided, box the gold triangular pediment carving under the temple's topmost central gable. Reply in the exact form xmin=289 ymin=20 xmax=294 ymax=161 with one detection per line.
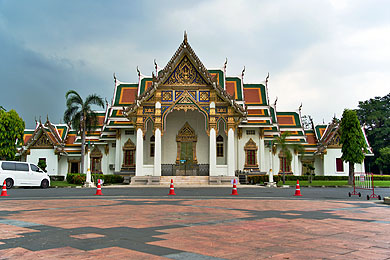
xmin=163 ymin=56 xmax=207 ymax=86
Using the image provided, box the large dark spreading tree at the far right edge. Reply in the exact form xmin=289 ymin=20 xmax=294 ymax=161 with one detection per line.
xmin=356 ymin=94 xmax=390 ymax=173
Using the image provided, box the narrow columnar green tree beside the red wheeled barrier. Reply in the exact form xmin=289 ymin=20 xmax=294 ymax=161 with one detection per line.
xmin=340 ymin=109 xmax=366 ymax=185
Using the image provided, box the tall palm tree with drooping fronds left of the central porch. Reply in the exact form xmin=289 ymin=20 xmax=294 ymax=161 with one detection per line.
xmin=64 ymin=90 xmax=104 ymax=173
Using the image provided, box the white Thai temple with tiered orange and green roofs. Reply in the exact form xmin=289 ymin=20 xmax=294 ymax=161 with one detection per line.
xmin=20 ymin=35 xmax=372 ymax=184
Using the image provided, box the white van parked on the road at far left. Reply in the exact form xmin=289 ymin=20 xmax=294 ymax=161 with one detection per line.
xmin=0 ymin=161 xmax=50 ymax=189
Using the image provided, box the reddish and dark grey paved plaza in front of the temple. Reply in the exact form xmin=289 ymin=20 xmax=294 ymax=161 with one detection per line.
xmin=0 ymin=188 xmax=390 ymax=259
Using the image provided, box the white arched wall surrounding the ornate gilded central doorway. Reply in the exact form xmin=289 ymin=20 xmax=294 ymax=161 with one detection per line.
xmin=161 ymin=110 xmax=209 ymax=164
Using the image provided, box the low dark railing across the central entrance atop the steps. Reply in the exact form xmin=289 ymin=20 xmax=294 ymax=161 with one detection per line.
xmin=161 ymin=164 xmax=210 ymax=176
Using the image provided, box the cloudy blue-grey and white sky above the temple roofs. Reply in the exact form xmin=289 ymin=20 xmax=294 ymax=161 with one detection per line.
xmin=0 ymin=0 xmax=390 ymax=128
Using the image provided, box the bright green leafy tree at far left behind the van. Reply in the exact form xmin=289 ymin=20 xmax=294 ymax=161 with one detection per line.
xmin=0 ymin=109 xmax=25 ymax=160
